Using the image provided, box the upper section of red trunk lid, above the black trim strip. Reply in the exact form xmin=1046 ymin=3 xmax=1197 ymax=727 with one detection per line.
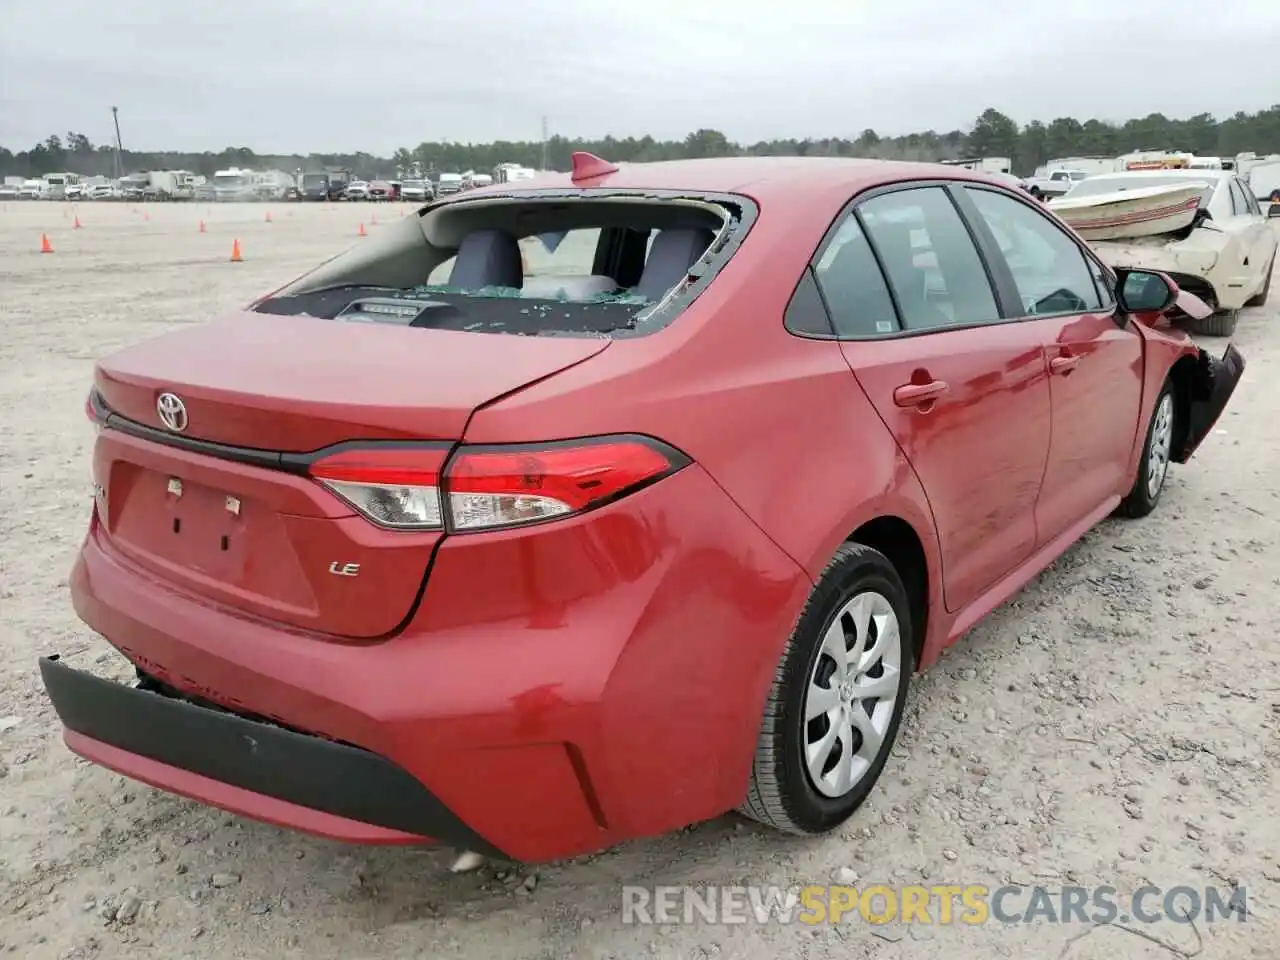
xmin=95 ymin=312 xmax=609 ymax=453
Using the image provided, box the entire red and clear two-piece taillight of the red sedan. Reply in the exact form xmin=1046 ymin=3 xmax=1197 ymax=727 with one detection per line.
xmin=308 ymin=436 xmax=689 ymax=532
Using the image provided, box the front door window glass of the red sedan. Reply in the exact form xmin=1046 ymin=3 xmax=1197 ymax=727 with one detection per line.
xmin=965 ymin=187 xmax=1102 ymax=316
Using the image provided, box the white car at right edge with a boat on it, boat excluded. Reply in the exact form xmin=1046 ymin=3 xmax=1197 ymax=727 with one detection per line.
xmin=1051 ymin=169 xmax=1280 ymax=337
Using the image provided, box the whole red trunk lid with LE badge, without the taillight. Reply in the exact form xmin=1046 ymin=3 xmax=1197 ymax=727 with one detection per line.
xmin=93 ymin=314 xmax=608 ymax=640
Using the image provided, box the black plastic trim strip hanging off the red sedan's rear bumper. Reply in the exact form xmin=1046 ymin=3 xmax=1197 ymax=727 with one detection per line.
xmin=40 ymin=655 xmax=507 ymax=859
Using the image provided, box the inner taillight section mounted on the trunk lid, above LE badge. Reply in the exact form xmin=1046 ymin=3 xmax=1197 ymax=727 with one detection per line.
xmin=307 ymin=445 xmax=448 ymax=530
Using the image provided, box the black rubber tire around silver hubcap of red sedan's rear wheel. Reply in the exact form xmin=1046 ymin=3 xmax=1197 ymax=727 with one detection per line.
xmin=739 ymin=543 xmax=915 ymax=836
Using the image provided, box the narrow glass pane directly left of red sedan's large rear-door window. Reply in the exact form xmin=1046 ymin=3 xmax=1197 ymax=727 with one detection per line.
xmin=814 ymin=214 xmax=899 ymax=337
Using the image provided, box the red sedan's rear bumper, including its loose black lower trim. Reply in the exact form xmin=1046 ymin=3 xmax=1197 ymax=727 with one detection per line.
xmin=55 ymin=465 xmax=812 ymax=861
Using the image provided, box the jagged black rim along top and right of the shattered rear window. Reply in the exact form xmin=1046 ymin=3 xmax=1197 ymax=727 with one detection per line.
xmin=417 ymin=187 xmax=760 ymax=340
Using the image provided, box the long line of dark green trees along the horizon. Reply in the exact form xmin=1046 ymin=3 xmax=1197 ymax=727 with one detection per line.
xmin=0 ymin=104 xmax=1280 ymax=178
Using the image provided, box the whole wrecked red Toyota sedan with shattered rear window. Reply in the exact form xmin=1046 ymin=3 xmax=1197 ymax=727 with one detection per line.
xmin=40 ymin=155 xmax=1243 ymax=860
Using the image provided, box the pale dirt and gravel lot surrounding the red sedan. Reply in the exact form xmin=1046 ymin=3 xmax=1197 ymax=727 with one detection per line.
xmin=0 ymin=204 xmax=1280 ymax=960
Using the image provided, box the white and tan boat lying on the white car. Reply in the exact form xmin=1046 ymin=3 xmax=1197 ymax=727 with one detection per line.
xmin=1050 ymin=182 xmax=1207 ymax=241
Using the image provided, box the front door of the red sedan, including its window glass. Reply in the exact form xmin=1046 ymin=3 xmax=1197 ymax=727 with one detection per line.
xmin=964 ymin=186 xmax=1143 ymax=544
